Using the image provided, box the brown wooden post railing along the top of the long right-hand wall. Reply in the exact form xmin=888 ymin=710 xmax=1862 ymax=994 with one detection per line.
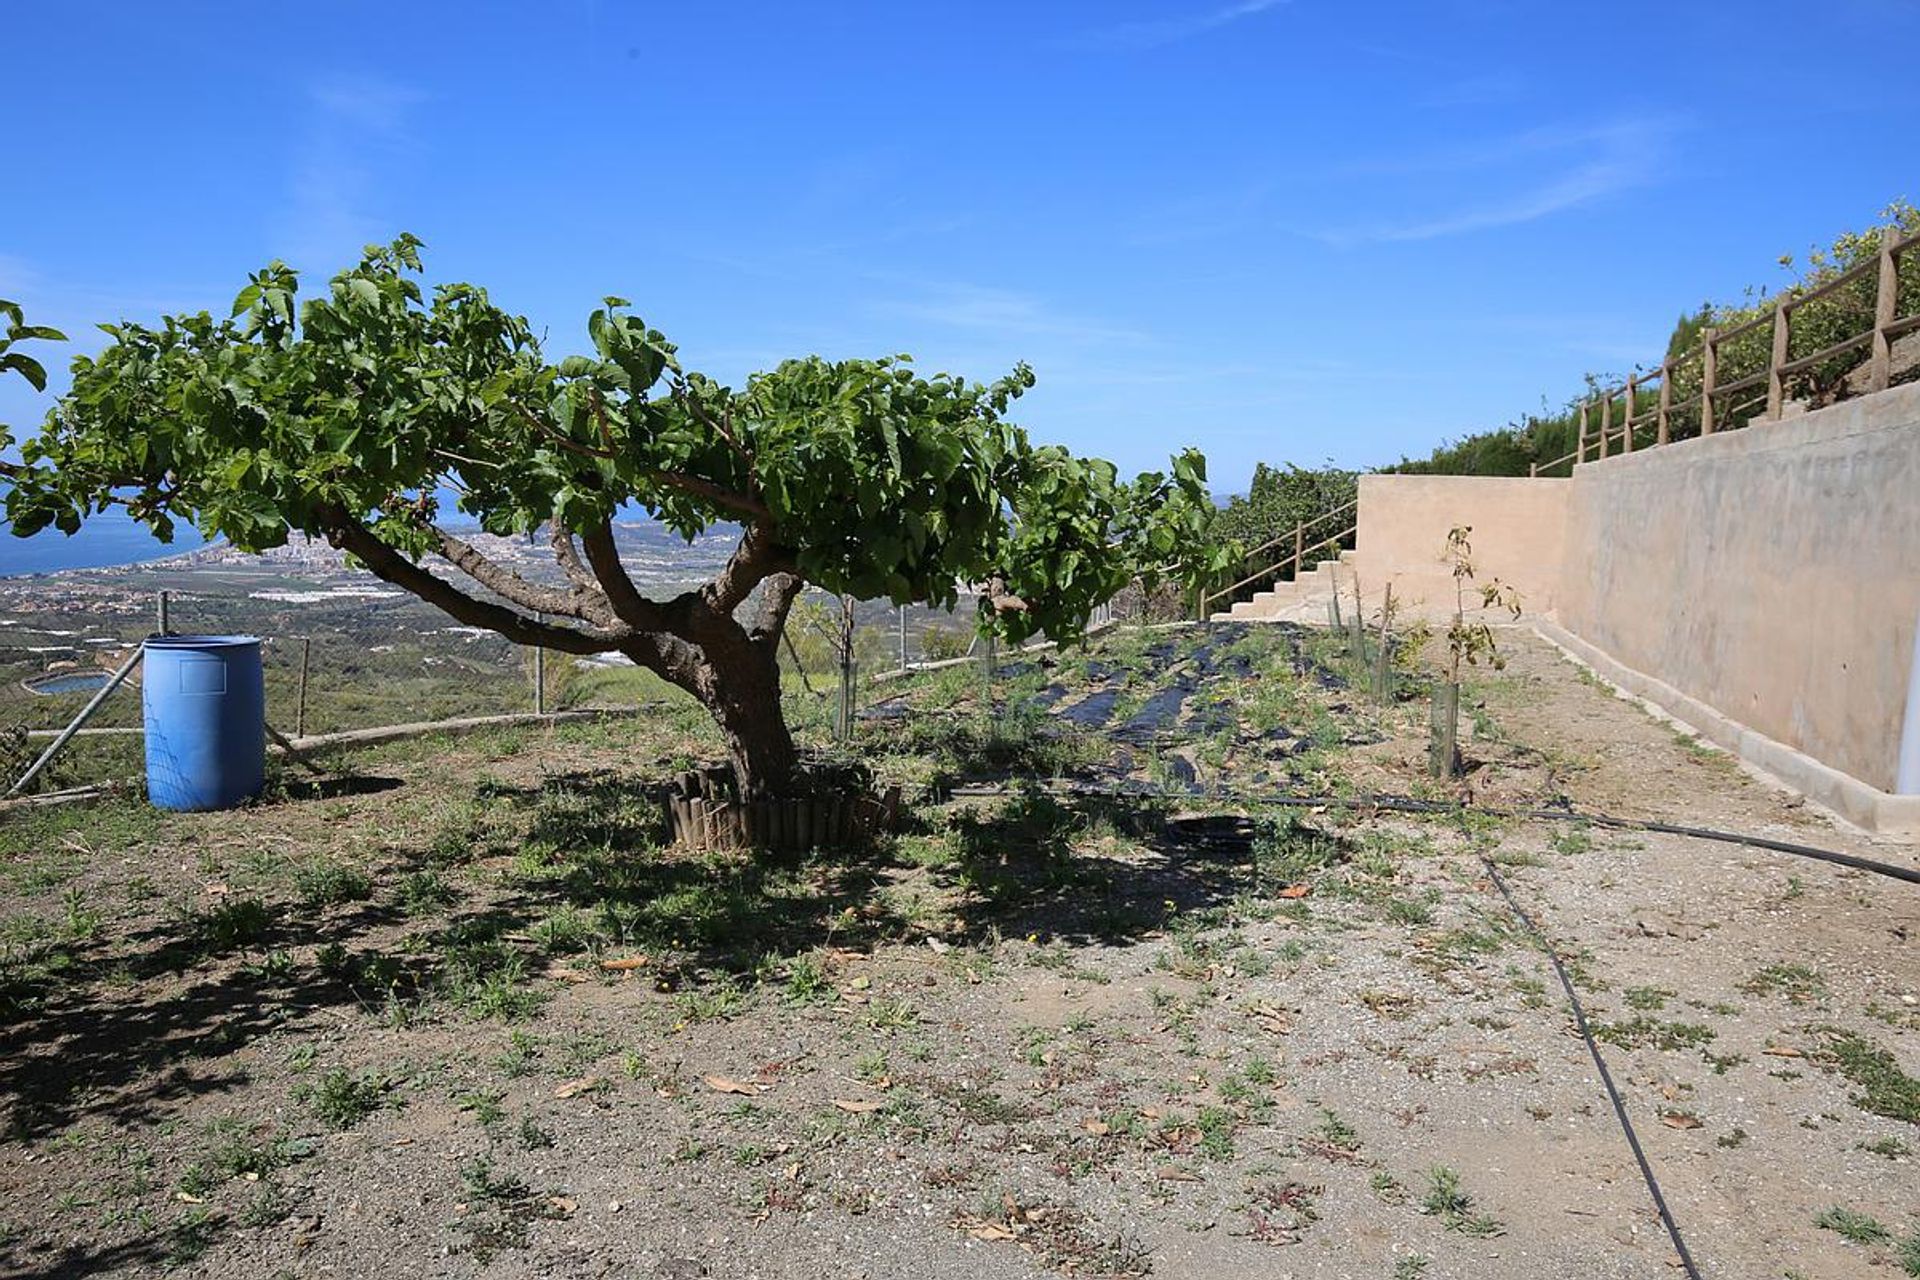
xmin=1526 ymin=226 xmax=1920 ymax=476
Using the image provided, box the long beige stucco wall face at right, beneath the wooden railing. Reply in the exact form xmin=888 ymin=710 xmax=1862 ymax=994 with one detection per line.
xmin=1559 ymin=386 xmax=1920 ymax=791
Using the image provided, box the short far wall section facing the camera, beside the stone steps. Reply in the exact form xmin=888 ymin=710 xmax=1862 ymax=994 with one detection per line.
xmin=1354 ymin=476 xmax=1572 ymax=616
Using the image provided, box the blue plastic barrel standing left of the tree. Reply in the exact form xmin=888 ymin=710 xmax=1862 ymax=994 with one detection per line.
xmin=140 ymin=635 xmax=267 ymax=810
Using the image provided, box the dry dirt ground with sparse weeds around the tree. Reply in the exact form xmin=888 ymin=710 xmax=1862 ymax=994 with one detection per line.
xmin=0 ymin=626 xmax=1920 ymax=1280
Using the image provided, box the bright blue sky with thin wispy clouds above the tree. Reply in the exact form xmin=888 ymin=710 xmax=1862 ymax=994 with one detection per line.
xmin=0 ymin=0 xmax=1920 ymax=489
